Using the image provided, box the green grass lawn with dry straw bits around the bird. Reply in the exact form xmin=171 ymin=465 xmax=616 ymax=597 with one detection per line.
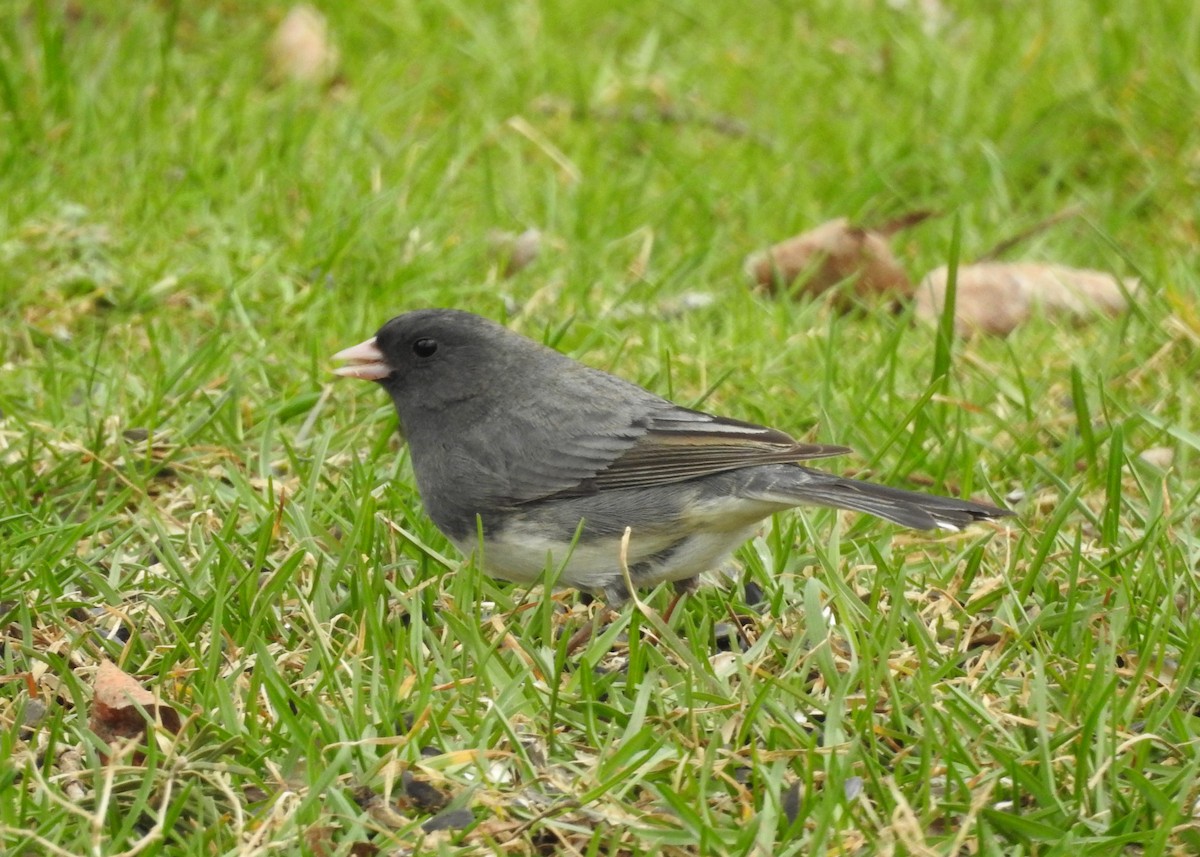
xmin=0 ymin=0 xmax=1200 ymax=855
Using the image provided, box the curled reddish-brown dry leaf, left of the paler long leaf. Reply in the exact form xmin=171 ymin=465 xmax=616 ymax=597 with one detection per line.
xmin=745 ymin=217 xmax=912 ymax=307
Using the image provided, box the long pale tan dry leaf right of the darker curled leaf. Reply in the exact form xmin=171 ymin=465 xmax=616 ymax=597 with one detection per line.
xmin=917 ymin=262 xmax=1138 ymax=336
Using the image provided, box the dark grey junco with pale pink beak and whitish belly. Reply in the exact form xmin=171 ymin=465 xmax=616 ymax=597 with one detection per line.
xmin=335 ymin=310 xmax=1012 ymax=606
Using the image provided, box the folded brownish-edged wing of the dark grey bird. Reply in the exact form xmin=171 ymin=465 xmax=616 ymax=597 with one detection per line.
xmin=528 ymin=406 xmax=850 ymax=497
